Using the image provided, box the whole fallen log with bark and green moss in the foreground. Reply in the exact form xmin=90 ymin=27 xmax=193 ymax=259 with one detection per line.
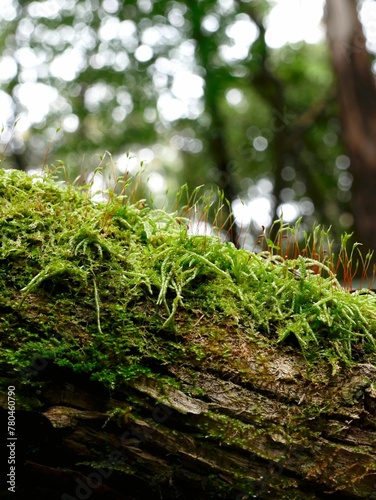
xmin=0 ymin=172 xmax=376 ymax=500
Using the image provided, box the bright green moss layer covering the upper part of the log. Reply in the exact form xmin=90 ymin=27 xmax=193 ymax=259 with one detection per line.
xmin=0 ymin=169 xmax=376 ymax=387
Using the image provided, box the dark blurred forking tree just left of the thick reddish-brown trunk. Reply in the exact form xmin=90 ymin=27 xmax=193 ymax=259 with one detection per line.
xmin=240 ymin=2 xmax=332 ymax=234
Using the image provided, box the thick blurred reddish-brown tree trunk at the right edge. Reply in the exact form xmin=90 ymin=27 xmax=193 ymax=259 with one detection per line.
xmin=326 ymin=0 xmax=376 ymax=251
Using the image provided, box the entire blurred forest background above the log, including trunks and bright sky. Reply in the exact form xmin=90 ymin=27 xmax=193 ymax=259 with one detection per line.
xmin=0 ymin=0 xmax=376 ymax=258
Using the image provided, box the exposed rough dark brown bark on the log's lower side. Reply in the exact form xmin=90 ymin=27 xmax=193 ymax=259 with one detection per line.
xmin=2 ymin=352 xmax=376 ymax=500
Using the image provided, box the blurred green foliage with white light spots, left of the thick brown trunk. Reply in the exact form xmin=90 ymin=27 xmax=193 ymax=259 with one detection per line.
xmin=0 ymin=0 xmax=350 ymax=242
